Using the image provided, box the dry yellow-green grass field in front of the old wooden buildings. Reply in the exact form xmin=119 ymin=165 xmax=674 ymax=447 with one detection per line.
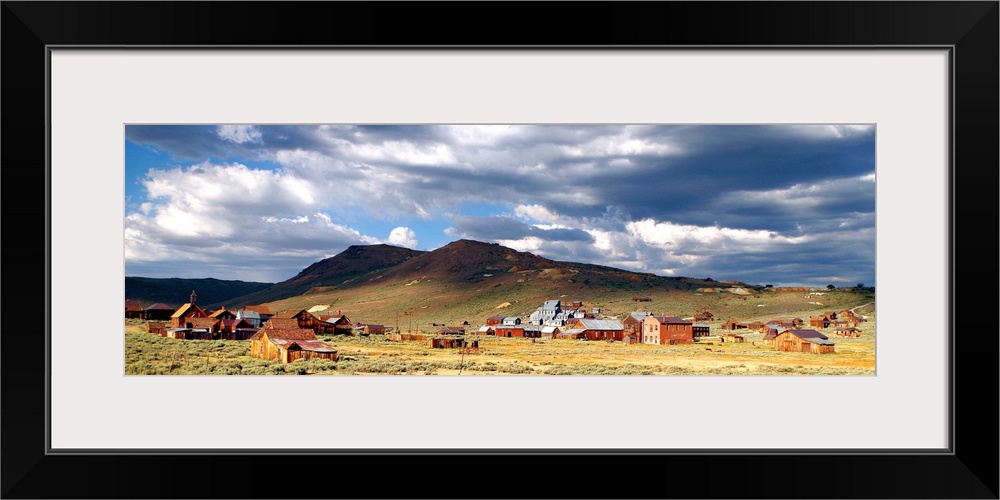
xmin=125 ymin=295 xmax=876 ymax=376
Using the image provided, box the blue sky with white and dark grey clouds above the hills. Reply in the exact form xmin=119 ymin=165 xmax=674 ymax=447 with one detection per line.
xmin=125 ymin=125 xmax=875 ymax=286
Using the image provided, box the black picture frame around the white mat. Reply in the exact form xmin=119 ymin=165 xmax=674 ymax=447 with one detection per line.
xmin=0 ymin=1 xmax=1000 ymax=498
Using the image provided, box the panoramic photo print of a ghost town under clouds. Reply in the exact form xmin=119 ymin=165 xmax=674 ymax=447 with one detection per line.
xmin=123 ymin=124 xmax=876 ymax=376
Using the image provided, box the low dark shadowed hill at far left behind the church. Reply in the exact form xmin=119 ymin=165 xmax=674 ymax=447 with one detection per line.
xmin=125 ymin=276 xmax=273 ymax=307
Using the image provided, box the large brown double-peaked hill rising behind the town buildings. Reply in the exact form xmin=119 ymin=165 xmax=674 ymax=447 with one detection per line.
xmin=221 ymin=240 xmax=820 ymax=327
